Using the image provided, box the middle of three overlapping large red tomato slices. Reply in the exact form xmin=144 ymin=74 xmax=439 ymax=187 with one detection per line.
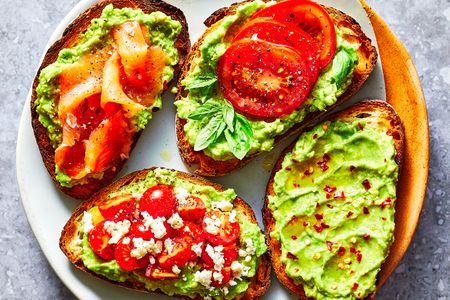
xmin=233 ymin=18 xmax=321 ymax=85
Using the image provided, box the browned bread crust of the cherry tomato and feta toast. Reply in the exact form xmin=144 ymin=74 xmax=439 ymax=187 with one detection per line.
xmin=59 ymin=168 xmax=271 ymax=299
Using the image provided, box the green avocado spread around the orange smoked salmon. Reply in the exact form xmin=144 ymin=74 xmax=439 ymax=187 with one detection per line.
xmin=34 ymin=4 xmax=181 ymax=187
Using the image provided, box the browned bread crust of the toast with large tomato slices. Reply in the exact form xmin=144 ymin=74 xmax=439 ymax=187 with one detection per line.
xmin=176 ymin=0 xmax=378 ymax=176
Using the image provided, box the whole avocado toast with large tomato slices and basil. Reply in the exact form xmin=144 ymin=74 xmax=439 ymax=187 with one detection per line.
xmin=175 ymin=0 xmax=377 ymax=176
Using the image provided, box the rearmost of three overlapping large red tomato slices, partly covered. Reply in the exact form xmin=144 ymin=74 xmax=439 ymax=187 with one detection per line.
xmin=252 ymin=0 xmax=336 ymax=68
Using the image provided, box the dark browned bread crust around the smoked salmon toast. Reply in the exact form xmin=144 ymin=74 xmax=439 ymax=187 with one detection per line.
xmin=30 ymin=0 xmax=190 ymax=199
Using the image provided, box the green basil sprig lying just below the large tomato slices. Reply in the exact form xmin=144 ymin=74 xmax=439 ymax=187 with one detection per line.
xmin=188 ymin=100 xmax=253 ymax=159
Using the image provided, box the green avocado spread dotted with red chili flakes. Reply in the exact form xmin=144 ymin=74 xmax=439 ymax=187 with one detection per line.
xmin=269 ymin=121 xmax=398 ymax=299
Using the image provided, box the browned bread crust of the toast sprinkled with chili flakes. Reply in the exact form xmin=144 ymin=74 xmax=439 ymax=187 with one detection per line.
xmin=263 ymin=100 xmax=404 ymax=299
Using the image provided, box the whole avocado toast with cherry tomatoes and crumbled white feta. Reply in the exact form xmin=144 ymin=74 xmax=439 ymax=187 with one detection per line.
xmin=60 ymin=168 xmax=270 ymax=299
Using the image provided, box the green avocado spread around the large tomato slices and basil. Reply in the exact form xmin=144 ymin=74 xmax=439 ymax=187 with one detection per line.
xmin=175 ymin=0 xmax=359 ymax=160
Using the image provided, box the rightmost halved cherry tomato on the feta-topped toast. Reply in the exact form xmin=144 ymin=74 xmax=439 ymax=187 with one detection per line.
xmin=202 ymin=210 xmax=241 ymax=245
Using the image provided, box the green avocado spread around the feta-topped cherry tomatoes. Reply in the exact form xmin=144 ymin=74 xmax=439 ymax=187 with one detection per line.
xmin=80 ymin=169 xmax=267 ymax=299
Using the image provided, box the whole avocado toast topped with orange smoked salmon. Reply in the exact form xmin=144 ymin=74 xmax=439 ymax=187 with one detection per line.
xmin=31 ymin=0 xmax=190 ymax=199
